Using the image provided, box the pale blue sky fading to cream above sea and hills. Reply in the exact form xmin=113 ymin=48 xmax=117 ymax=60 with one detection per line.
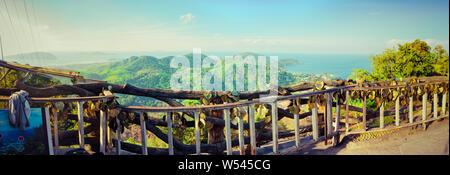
xmin=0 ymin=0 xmax=449 ymax=55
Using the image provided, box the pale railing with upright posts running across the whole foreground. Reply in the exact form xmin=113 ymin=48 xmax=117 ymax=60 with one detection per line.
xmin=0 ymin=80 xmax=448 ymax=155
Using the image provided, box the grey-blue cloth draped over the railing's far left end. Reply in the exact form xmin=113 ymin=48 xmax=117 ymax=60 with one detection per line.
xmin=9 ymin=90 xmax=31 ymax=131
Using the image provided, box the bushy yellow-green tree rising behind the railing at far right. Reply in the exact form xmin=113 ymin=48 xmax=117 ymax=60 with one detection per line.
xmin=349 ymin=39 xmax=449 ymax=81
